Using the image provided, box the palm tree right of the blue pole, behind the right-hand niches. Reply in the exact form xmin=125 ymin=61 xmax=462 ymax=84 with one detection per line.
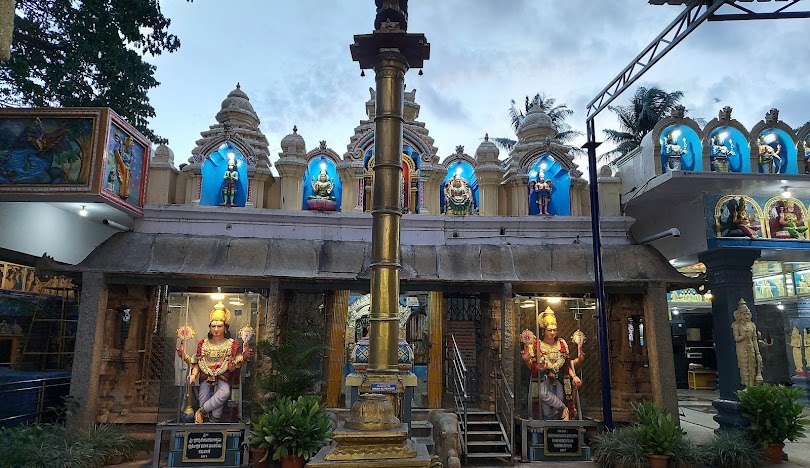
xmin=600 ymin=86 xmax=683 ymax=163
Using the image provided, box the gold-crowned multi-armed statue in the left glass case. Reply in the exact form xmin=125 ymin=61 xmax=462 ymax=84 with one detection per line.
xmin=177 ymin=301 xmax=252 ymax=424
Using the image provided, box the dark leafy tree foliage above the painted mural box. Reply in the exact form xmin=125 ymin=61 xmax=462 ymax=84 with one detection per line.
xmin=0 ymin=0 xmax=191 ymax=143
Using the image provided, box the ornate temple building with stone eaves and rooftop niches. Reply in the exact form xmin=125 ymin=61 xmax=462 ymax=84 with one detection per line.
xmin=0 ymin=79 xmax=810 ymax=458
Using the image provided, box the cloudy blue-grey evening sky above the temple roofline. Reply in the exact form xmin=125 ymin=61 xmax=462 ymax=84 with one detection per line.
xmin=149 ymin=0 xmax=810 ymax=173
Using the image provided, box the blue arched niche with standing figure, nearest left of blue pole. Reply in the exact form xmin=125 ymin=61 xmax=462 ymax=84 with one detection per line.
xmin=528 ymin=153 xmax=571 ymax=216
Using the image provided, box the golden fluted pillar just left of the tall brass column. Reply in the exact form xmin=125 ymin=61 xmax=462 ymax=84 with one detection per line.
xmin=326 ymin=289 xmax=349 ymax=408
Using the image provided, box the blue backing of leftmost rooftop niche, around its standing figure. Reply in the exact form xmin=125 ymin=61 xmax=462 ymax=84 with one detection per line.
xmin=200 ymin=142 xmax=248 ymax=206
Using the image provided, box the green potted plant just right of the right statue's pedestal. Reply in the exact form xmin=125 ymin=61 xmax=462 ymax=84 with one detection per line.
xmin=633 ymin=401 xmax=683 ymax=468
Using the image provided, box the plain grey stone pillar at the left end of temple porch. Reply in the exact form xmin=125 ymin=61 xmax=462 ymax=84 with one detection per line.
xmin=68 ymin=272 xmax=107 ymax=429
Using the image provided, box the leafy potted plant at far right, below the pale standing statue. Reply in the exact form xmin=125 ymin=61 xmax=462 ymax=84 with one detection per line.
xmin=736 ymin=383 xmax=810 ymax=464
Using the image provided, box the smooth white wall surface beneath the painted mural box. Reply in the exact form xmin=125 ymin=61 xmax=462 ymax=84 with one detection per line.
xmin=0 ymin=202 xmax=118 ymax=264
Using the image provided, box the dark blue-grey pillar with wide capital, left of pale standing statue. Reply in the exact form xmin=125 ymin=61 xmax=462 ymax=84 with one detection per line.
xmin=698 ymin=249 xmax=761 ymax=430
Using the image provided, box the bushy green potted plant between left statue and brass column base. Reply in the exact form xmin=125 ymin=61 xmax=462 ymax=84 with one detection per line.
xmin=250 ymin=396 xmax=332 ymax=468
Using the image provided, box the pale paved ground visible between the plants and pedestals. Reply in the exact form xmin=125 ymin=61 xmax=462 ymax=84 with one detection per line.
xmin=107 ymin=390 xmax=810 ymax=468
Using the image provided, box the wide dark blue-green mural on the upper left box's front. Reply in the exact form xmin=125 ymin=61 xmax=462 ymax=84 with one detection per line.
xmin=0 ymin=114 xmax=96 ymax=189
